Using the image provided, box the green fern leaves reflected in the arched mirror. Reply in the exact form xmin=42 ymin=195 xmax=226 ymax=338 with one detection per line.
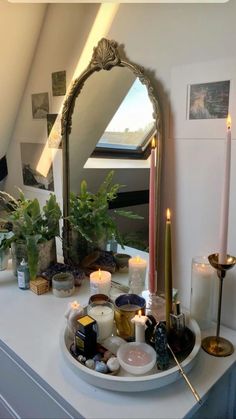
xmin=68 ymin=170 xmax=143 ymax=246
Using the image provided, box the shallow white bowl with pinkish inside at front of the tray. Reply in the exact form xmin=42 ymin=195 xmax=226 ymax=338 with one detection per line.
xmin=117 ymin=342 xmax=156 ymax=375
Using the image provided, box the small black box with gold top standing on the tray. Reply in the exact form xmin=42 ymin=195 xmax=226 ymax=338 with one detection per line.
xmin=75 ymin=315 xmax=97 ymax=359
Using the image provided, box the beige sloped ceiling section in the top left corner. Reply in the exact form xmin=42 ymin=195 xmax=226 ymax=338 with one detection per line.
xmin=0 ymin=0 xmax=47 ymax=158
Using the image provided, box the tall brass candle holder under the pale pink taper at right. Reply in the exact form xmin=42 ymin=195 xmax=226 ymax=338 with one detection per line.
xmin=202 ymin=253 xmax=236 ymax=357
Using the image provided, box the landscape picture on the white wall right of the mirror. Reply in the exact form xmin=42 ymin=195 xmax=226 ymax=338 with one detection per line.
xmin=188 ymin=80 xmax=230 ymax=119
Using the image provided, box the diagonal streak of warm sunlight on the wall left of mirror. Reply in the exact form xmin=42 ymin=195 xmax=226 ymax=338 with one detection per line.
xmin=36 ymin=3 xmax=120 ymax=177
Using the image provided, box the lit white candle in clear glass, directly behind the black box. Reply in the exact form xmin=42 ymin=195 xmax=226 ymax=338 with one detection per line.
xmin=87 ymin=303 xmax=114 ymax=342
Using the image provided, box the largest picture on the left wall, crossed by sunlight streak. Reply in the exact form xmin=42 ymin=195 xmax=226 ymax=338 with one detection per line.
xmin=20 ymin=143 xmax=54 ymax=191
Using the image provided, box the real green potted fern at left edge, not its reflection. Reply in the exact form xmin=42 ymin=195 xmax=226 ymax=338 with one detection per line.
xmin=0 ymin=190 xmax=61 ymax=279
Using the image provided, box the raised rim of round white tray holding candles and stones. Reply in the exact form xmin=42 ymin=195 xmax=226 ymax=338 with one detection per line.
xmin=60 ymin=319 xmax=201 ymax=392
